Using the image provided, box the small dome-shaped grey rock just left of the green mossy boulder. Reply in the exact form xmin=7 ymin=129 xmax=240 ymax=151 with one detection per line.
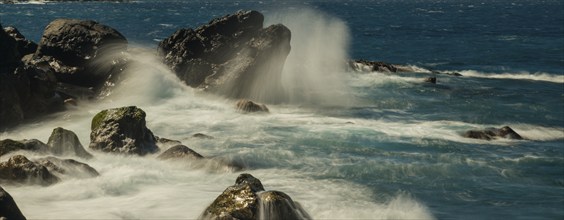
xmin=47 ymin=127 xmax=92 ymax=158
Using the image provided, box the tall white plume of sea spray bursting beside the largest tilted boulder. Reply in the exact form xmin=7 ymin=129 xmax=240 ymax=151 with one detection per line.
xmin=265 ymin=9 xmax=354 ymax=106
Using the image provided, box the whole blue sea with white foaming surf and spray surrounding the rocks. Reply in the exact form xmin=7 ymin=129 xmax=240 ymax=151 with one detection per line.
xmin=0 ymin=0 xmax=564 ymax=219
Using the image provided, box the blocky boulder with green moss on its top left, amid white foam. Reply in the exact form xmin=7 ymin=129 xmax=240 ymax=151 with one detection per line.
xmin=89 ymin=106 xmax=159 ymax=155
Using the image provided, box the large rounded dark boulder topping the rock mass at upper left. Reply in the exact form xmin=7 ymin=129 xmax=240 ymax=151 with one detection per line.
xmin=33 ymin=19 xmax=127 ymax=88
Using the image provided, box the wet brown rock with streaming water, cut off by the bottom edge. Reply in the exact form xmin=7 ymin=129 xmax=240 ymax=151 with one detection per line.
xmin=200 ymin=174 xmax=311 ymax=220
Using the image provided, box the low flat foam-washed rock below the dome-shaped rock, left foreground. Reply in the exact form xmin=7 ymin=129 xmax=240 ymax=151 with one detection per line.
xmin=36 ymin=157 xmax=100 ymax=178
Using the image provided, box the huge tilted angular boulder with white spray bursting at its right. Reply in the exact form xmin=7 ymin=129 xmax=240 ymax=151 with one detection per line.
xmin=158 ymin=11 xmax=291 ymax=101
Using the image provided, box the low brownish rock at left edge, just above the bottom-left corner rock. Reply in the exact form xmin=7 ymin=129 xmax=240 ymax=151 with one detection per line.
xmin=0 ymin=155 xmax=59 ymax=185
